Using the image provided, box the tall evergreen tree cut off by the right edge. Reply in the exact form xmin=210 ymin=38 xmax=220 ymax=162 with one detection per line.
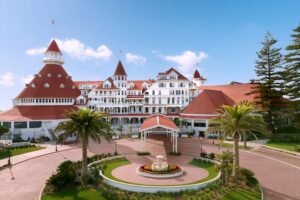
xmin=283 ymin=24 xmax=300 ymax=126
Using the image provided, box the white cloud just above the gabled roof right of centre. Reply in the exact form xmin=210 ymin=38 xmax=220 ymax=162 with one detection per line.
xmin=163 ymin=50 xmax=208 ymax=77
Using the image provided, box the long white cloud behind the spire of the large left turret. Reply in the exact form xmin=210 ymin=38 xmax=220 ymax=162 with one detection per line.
xmin=25 ymin=38 xmax=112 ymax=60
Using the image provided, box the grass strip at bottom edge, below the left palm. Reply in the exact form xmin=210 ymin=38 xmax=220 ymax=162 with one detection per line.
xmin=42 ymin=189 xmax=105 ymax=200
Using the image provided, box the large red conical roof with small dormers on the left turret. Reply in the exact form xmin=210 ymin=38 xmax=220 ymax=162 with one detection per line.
xmin=16 ymin=64 xmax=80 ymax=98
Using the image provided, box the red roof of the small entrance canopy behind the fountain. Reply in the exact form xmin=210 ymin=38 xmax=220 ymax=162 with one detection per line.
xmin=139 ymin=115 xmax=178 ymax=131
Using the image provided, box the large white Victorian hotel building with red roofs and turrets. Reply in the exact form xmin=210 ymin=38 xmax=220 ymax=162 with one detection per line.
xmin=0 ymin=41 xmax=254 ymax=139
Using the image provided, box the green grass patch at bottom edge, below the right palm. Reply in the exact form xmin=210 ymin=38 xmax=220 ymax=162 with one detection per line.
xmin=221 ymin=188 xmax=261 ymax=200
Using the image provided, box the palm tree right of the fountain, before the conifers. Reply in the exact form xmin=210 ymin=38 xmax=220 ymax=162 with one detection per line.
xmin=207 ymin=101 xmax=271 ymax=178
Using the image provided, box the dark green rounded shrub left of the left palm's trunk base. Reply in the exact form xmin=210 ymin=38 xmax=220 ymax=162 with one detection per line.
xmin=47 ymin=160 xmax=76 ymax=189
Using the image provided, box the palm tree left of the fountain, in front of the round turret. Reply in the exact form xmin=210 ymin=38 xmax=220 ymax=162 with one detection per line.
xmin=55 ymin=109 xmax=111 ymax=176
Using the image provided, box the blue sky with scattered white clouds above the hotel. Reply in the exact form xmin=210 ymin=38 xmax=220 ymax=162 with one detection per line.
xmin=0 ymin=0 xmax=300 ymax=109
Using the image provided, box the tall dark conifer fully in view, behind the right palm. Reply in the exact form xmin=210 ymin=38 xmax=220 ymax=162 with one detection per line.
xmin=254 ymin=32 xmax=283 ymax=128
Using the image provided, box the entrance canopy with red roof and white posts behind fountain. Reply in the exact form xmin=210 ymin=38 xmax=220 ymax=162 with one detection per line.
xmin=139 ymin=114 xmax=179 ymax=153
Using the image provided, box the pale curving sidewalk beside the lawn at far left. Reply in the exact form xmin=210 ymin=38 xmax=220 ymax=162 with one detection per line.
xmin=0 ymin=144 xmax=77 ymax=166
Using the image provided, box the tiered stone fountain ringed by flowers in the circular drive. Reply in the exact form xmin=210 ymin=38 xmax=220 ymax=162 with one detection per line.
xmin=137 ymin=155 xmax=184 ymax=178
